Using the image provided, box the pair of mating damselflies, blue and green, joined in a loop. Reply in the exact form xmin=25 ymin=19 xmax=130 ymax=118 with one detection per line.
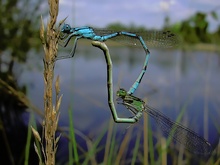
xmin=57 ymin=24 xmax=212 ymax=154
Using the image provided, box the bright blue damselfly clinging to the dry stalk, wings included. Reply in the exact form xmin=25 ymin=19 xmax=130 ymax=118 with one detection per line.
xmin=57 ymin=24 xmax=178 ymax=94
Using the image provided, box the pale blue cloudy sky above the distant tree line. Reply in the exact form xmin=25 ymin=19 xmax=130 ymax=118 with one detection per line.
xmin=58 ymin=0 xmax=220 ymax=31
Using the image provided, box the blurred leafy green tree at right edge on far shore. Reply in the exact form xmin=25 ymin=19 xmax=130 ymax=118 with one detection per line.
xmin=164 ymin=11 xmax=220 ymax=44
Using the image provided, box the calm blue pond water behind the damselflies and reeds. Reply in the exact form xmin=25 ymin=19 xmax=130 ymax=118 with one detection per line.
xmin=20 ymin=44 xmax=220 ymax=164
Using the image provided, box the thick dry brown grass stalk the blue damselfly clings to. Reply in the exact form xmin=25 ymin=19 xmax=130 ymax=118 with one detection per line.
xmin=37 ymin=0 xmax=62 ymax=165
